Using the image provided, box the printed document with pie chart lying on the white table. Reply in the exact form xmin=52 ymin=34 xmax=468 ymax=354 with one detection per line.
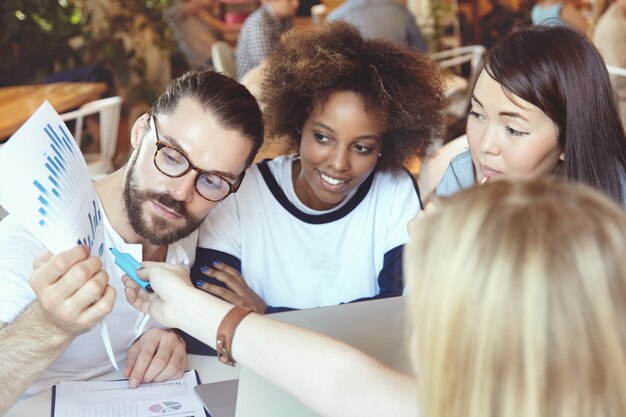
xmin=52 ymin=369 xmax=208 ymax=417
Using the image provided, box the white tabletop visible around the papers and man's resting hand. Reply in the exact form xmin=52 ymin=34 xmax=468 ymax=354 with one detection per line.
xmin=4 ymin=355 xmax=240 ymax=417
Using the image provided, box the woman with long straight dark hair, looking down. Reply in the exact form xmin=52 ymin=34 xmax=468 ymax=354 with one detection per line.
xmin=437 ymin=26 xmax=626 ymax=204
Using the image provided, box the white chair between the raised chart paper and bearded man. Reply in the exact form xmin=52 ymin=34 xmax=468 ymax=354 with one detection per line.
xmin=61 ymin=96 xmax=122 ymax=178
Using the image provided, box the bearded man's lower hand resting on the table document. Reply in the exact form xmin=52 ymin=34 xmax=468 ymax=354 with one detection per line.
xmin=124 ymin=329 xmax=187 ymax=388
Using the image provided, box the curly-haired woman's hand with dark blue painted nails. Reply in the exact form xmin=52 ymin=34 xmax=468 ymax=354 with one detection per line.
xmin=196 ymin=261 xmax=267 ymax=314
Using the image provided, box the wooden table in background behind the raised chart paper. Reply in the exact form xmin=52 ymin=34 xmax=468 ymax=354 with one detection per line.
xmin=0 ymin=83 xmax=107 ymax=143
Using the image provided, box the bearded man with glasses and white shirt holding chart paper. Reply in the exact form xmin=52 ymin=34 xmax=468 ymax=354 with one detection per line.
xmin=0 ymin=71 xmax=263 ymax=414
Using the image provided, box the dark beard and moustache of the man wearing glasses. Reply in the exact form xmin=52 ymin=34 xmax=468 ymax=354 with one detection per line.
xmin=124 ymin=158 xmax=203 ymax=245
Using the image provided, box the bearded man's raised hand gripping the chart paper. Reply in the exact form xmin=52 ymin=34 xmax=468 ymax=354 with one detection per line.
xmin=30 ymin=246 xmax=115 ymax=336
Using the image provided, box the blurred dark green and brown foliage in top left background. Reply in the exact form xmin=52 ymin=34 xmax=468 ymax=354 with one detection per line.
xmin=0 ymin=0 xmax=175 ymax=107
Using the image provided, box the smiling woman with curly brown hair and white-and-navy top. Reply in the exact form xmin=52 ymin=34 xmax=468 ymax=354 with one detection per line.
xmin=192 ymin=23 xmax=446 ymax=312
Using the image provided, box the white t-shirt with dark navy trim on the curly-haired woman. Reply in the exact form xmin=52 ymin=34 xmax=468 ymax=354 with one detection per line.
xmin=192 ymin=155 xmax=421 ymax=311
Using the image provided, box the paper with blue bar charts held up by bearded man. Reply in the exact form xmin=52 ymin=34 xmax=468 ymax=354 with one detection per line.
xmin=0 ymin=101 xmax=104 ymax=257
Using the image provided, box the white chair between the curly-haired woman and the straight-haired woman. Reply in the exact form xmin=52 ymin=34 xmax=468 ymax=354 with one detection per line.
xmin=430 ymin=45 xmax=486 ymax=118
